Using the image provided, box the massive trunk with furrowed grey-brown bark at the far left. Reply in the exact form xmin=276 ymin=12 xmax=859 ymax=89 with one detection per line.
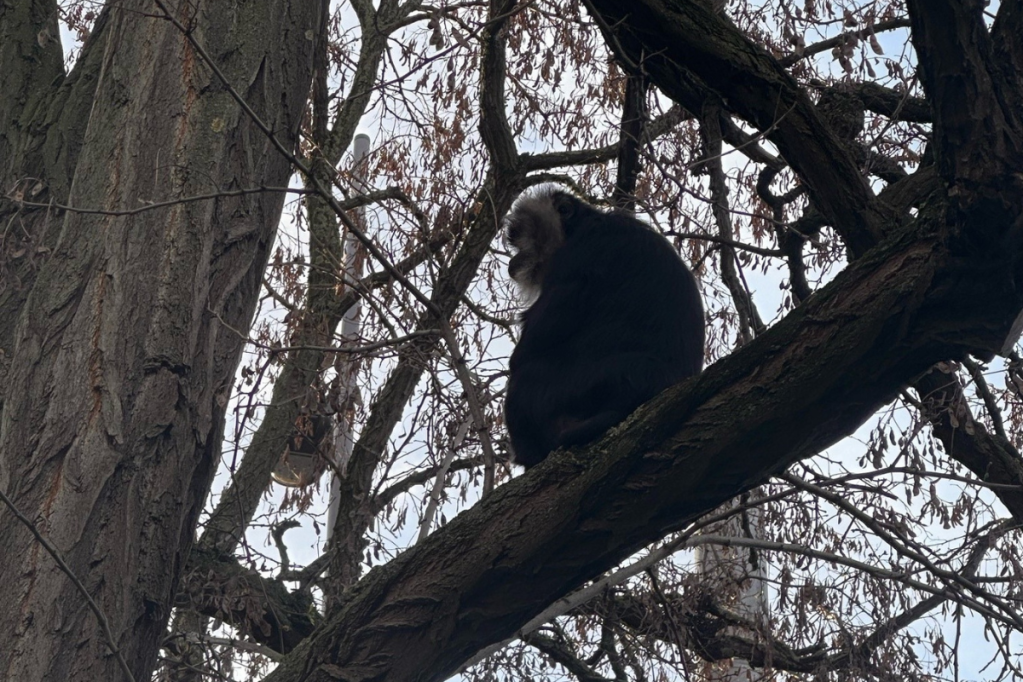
xmin=0 ymin=0 xmax=319 ymax=681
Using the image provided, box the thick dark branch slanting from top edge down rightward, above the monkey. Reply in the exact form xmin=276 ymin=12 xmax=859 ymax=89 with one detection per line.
xmin=587 ymin=0 xmax=884 ymax=255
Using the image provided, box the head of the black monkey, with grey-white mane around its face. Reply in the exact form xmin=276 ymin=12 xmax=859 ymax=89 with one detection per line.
xmin=504 ymin=185 xmax=584 ymax=300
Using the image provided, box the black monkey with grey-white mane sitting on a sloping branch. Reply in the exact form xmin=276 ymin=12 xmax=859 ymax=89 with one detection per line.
xmin=504 ymin=186 xmax=704 ymax=467
